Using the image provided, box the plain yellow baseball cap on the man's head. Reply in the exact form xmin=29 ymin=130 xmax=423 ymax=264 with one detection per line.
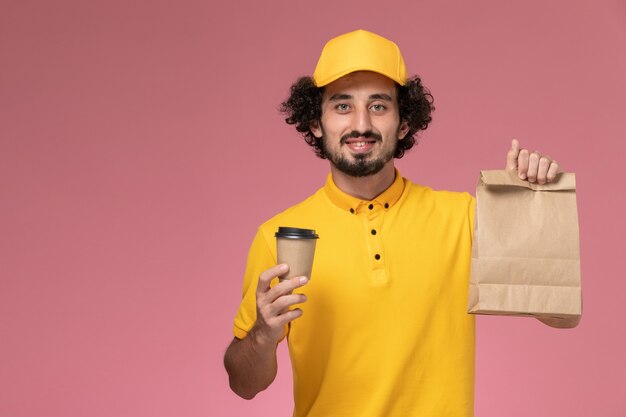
xmin=313 ymin=29 xmax=406 ymax=87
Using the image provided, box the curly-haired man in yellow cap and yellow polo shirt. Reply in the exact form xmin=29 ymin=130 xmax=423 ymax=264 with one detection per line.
xmin=224 ymin=30 xmax=559 ymax=417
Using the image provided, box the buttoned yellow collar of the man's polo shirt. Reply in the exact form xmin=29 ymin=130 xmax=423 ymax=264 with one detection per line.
xmin=324 ymin=169 xmax=404 ymax=213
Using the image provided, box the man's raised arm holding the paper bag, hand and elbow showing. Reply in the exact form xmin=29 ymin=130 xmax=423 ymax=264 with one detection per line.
xmin=506 ymin=139 xmax=580 ymax=329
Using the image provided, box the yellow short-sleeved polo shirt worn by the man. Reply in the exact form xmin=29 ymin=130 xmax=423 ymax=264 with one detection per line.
xmin=234 ymin=172 xmax=474 ymax=417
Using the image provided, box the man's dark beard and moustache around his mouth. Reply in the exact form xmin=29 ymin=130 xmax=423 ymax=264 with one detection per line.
xmin=322 ymin=129 xmax=398 ymax=177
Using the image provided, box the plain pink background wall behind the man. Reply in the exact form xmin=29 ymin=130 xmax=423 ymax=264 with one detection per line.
xmin=0 ymin=0 xmax=626 ymax=417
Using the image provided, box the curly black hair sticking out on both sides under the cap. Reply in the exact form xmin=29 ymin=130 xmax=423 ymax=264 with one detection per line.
xmin=279 ymin=76 xmax=435 ymax=159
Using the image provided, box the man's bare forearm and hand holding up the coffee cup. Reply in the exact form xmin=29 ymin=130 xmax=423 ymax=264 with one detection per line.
xmin=224 ymin=264 xmax=308 ymax=400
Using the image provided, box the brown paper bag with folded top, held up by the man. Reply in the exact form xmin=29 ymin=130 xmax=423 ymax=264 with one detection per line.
xmin=468 ymin=171 xmax=582 ymax=319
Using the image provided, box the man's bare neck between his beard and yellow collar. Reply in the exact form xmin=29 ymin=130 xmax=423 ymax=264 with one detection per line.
xmin=330 ymin=160 xmax=396 ymax=200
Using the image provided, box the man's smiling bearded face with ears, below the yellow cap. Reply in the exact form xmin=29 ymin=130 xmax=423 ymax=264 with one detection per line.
xmin=311 ymin=71 xmax=409 ymax=177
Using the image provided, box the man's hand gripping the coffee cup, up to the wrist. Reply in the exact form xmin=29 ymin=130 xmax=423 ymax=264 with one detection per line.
xmin=250 ymin=264 xmax=308 ymax=345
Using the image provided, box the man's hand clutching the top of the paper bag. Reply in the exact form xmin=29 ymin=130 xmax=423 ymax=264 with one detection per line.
xmin=506 ymin=139 xmax=561 ymax=184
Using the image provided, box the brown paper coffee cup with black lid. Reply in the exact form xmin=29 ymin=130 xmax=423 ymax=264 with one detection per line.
xmin=274 ymin=227 xmax=319 ymax=280
